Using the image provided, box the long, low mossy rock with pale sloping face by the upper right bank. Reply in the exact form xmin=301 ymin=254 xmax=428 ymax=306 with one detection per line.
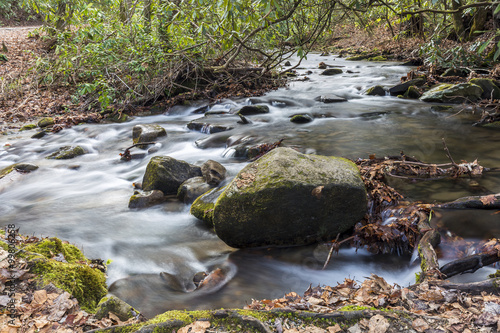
xmin=420 ymin=83 xmax=483 ymax=103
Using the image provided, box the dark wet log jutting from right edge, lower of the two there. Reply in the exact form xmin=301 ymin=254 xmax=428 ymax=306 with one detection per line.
xmin=439 ymin=249 xmax=500 ymax=278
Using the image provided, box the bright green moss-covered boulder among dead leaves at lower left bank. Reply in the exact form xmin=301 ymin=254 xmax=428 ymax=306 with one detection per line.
xmin=22 ymin=238 xmax=107 ymax=312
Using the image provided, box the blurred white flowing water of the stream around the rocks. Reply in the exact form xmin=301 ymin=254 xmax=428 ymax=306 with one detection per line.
xmin=0 ymin=55 xmax=500 ymax=316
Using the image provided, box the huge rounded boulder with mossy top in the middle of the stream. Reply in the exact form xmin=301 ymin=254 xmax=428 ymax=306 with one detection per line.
xmin=213 ymin=148 xmax=367 ymax=248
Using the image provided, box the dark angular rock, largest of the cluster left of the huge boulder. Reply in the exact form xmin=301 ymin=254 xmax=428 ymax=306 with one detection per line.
xmin=142 ymin=156 xmax=201 ymax=195
